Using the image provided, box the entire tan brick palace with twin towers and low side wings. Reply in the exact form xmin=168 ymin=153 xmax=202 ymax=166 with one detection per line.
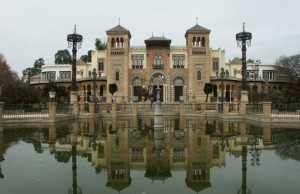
xmin=31 ymin=24 xmax=286 ymax=102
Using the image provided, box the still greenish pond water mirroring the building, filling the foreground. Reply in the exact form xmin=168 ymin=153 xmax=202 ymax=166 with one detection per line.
xmin=0 ymin=118 xmax=300 ymax=194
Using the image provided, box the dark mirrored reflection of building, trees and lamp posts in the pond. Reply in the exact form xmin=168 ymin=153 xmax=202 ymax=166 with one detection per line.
xmin=0 ymin=117 xmax=300 ymax=194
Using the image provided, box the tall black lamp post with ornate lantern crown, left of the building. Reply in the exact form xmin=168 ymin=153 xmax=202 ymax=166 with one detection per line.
xmin=67 ymin=25 xmax=82 ymax=103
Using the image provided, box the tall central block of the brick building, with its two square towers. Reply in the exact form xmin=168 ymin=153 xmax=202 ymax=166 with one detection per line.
xmin=92 ymin=21 xmax=225 ymax=102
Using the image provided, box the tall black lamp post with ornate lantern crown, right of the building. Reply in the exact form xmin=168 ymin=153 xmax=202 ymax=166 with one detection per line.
xmin=236 ymin=23 xmax=252 ymax=91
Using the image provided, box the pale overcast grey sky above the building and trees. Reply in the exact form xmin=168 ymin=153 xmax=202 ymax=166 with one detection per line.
xmin=0 ymin=0 xmax=300 ymax=76
